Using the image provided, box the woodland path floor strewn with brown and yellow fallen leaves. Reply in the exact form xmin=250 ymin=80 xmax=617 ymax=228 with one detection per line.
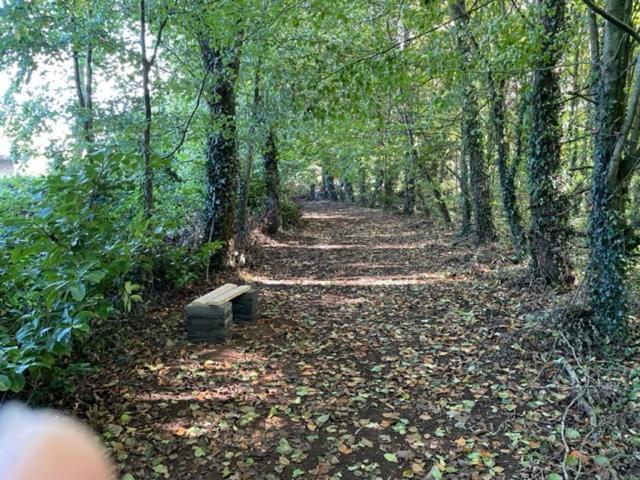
xmin=67 ymin=202 xmax=636 ymax=480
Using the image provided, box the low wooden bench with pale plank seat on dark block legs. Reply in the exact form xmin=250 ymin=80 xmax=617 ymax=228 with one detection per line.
xmin=186 ymin=283 xmax=260 ymax=343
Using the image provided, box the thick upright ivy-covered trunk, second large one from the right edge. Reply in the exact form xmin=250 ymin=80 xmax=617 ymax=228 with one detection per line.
xmin=527 ymin=0 xmax=573 ymax=284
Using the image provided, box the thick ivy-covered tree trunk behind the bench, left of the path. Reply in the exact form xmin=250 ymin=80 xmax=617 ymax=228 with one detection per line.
xmin=199 ymin=38 xmax=239 ymax=266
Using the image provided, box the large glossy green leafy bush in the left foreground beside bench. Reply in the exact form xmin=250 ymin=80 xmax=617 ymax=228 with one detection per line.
xmin=0 ymin=154 xmax=216 ymax=392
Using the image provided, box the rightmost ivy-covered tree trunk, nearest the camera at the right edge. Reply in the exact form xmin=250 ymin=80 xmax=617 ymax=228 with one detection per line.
xmin=587 ymin=0 xmax=640 ymax=340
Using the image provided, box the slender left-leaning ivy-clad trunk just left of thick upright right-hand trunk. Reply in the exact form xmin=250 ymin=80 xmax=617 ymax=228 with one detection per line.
xmin=489 ymin=75 xmax=525 ymax=255
